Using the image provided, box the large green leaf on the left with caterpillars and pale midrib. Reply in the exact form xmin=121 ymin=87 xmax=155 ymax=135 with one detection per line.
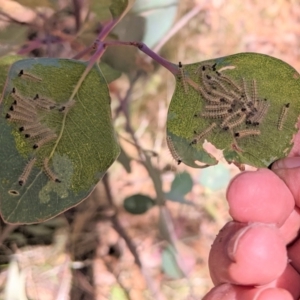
xmin=0 ymin=58 xmax=120 ymax=223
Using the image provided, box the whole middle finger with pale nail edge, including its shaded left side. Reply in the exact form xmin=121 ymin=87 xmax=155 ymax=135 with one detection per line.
xmin=209 ymin=222 xmax=287 ymax=285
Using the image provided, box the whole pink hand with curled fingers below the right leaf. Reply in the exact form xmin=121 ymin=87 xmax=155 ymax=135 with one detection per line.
xmin=203 ymin=137 xmax=300 ymax=300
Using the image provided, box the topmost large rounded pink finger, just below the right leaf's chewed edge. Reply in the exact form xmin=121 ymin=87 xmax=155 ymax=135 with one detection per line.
xmin=227 ymin=169 xmax=295 ymax=226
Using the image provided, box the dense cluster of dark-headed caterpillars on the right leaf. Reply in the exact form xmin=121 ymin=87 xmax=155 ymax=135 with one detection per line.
xmin=179 ymin=63 xmax=290 ymax=144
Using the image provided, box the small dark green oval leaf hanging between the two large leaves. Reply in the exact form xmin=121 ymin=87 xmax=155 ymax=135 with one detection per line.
xmin=124 ymin=194 xmax=155 ymax=215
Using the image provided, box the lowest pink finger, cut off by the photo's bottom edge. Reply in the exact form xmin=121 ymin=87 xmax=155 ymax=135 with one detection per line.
xmin=203 ymin=283 xmax=294 ymax=300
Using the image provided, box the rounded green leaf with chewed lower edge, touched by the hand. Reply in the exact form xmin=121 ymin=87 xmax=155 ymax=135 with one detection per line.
xmin=167 ymin=53 xmax=300 ymax=169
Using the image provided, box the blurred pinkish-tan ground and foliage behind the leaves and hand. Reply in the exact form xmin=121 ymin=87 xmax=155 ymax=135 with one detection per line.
xmin=0 ymin=0 xmax=300 ymax=300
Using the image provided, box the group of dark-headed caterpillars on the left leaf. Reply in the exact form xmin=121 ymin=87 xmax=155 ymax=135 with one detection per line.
xmin=6 ymin=70 xmax=75 ymax=186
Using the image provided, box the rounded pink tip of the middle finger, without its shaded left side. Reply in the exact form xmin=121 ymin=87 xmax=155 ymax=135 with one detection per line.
xmin=227 ymin=224 xmax=287 ymax=285
